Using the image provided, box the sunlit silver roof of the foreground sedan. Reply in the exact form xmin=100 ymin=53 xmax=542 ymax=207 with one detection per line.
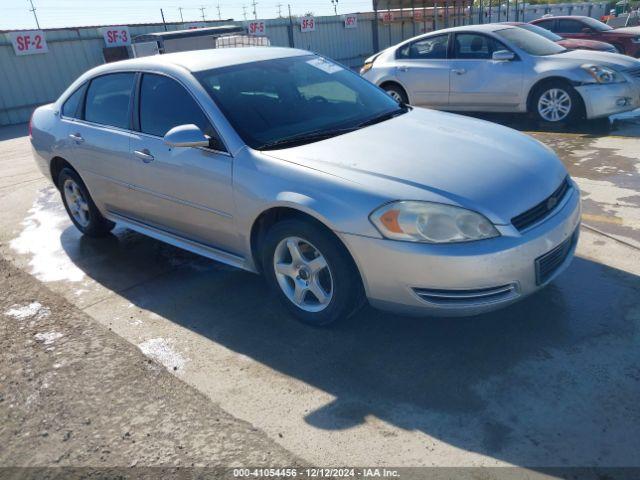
xmin=102 ymin=47 xmax=311 ymax=72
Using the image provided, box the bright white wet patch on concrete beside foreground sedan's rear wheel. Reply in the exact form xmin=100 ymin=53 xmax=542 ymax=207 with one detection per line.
xmin=10 ymin=186 xmax=84 ymax=282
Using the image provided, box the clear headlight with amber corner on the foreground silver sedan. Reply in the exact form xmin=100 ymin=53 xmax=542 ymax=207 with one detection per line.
xmin=369 ymin=201 xmax=500 ymax=243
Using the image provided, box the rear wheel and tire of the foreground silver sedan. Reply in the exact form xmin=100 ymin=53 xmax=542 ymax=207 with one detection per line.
xmin=58 ymin=168 xmax=115 ymax=237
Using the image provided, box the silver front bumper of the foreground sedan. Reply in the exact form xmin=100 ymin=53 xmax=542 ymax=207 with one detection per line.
xmin=340 ymin=186 xmax=581 ymax=316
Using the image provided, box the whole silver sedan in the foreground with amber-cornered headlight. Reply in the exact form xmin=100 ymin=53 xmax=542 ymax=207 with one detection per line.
xmin=31 ymin=48 xmax=580 ymax=325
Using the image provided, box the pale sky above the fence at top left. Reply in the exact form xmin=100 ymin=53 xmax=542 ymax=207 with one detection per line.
xmin=0 ymin=0 xmax=372 ymax=30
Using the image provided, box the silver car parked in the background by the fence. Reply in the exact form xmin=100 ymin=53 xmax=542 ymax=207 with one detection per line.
xmin=361 ymin=24 xmax=640 ymax=122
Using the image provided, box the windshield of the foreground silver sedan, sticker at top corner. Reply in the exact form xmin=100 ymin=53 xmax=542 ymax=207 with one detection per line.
xmin=194 ymin=55 xmax=408 ymax=150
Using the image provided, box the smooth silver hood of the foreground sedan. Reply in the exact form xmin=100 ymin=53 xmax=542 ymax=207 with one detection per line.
xmin=264 ymin=108 xmax=567 ymax=224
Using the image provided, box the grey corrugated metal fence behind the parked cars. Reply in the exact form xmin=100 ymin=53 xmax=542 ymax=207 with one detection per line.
xmin=0 ymin=2 xmax=606 ymax=125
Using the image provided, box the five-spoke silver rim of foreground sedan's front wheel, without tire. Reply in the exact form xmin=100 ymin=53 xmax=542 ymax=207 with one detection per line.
xmin=273 ymin=237 xmax=334 ymax=312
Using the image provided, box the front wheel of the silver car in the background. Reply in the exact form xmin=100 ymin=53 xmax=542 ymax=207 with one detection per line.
xmin=531 ymin=81 xmax=582 ymax=123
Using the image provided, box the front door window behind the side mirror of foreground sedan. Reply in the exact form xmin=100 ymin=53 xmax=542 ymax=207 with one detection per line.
xmin=140 ymin=73 xmax=215 ymax=137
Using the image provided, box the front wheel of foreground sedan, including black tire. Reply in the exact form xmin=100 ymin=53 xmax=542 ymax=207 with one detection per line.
xmin=262 ymin=219 xmax=364 ymax=326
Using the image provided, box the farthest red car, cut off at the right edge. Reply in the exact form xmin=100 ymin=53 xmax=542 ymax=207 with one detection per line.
xmin=530 ymin=16 xmax=640 ymax=58
